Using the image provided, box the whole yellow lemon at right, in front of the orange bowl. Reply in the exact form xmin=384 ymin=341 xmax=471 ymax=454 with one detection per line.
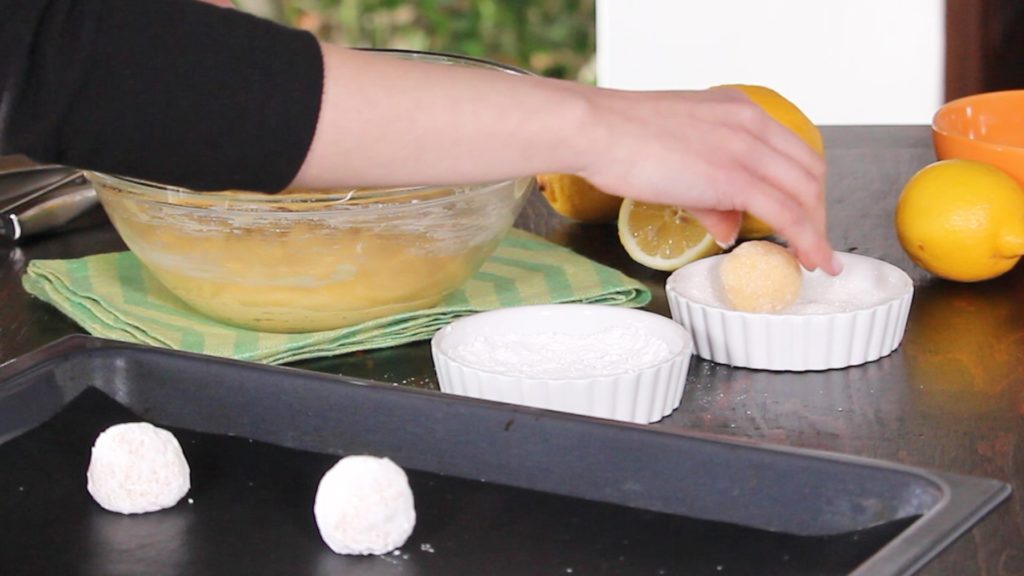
xmin=896 ymin=159 xmax=1024 ymax=282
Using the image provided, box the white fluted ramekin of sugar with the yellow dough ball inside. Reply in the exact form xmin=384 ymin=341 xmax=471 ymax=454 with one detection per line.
xmin=666 ymin=253 xmax=913 ymax=371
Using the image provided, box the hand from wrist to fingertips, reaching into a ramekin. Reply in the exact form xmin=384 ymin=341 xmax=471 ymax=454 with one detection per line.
xmin=581 ymin=88 xmax=841 ymax=274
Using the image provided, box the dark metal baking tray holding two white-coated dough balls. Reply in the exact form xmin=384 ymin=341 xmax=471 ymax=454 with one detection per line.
xmin=0 ymin=336 xmax=1009 ymax=574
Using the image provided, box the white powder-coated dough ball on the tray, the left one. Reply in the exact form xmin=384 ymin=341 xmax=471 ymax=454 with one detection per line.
xmin=86 ymin=422 xmax=190 ymax=515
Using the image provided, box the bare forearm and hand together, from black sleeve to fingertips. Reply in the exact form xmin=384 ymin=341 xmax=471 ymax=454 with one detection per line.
xmin=293 ymin=45 xmax=840 ymax=274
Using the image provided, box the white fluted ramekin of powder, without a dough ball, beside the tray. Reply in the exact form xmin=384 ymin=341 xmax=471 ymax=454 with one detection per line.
xmin=431 ymin=304 xmax=693 ymax=423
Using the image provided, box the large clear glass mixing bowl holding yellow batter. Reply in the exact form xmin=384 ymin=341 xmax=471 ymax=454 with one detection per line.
xmin=87 ymin=52 xmax=537 ymax=332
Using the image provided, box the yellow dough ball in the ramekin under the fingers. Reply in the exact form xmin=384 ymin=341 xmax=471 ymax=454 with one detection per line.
xmin=719 ymin=240 xmax=803 ymax=313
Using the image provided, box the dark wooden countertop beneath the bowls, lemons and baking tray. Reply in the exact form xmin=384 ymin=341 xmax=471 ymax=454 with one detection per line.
xmin=0 ymin=126 xmax=1024 ymax=576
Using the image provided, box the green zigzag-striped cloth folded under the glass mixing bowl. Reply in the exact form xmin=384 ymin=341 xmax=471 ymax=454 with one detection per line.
xmin=22 ymin=230 xmax=650 ymax=364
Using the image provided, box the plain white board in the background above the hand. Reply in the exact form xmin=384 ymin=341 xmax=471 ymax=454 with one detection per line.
xmin=597 ymin=0 xmax=945 ymax=125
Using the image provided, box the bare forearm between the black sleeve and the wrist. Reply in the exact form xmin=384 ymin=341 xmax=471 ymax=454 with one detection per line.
xmin=294 ymin=45 xmax=592 ymax=187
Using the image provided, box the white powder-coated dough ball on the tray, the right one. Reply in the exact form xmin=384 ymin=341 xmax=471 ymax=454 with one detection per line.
xmin=313 ymin=456 xmax=416 ymax=554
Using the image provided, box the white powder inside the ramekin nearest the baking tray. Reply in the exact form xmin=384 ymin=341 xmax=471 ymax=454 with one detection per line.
xmin=450 ymin=326 xmax=672 ymax=378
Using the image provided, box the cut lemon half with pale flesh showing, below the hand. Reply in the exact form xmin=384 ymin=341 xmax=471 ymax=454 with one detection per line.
xmin=618 ymin=200 xmax=722 ymax=272
